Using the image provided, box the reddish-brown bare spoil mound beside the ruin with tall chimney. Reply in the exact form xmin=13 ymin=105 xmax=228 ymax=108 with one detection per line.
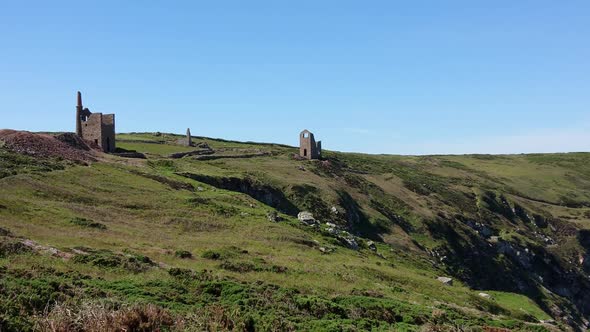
xmin=0 ymin=130 xmax=95 ymax=161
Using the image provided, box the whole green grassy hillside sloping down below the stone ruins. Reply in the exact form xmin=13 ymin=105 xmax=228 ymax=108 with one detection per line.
xmin=0 ymin=133 xmax=590 ymax=331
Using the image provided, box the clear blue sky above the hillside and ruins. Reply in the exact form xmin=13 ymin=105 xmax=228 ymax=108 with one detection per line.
xmin=0 ymin=0 xmax=590 ymax=154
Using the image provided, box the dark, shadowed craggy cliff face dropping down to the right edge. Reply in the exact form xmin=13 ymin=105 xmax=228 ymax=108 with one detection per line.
xmin=182 ymin=163 xmax=590 ymax=329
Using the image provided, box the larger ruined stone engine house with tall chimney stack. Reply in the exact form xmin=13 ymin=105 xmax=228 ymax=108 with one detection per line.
xmin=76 ymin=91 xmax=115 ymax=152
